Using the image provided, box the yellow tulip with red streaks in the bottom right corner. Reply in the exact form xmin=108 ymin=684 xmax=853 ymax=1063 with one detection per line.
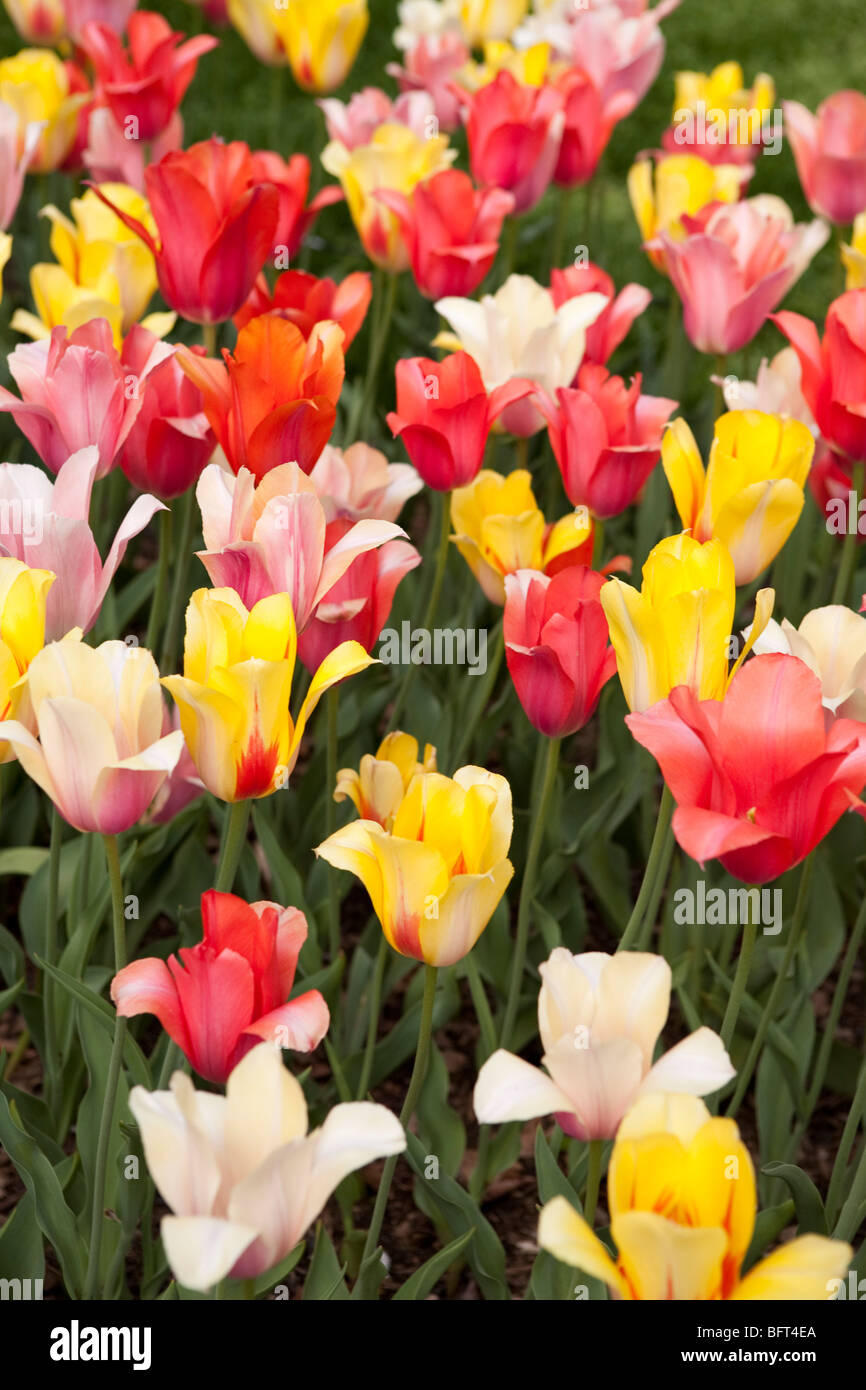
xmin=538 ymin=1095 xmax=853 ymax=1302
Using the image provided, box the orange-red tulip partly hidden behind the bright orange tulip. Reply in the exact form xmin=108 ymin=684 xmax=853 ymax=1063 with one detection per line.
xmin=234 ymin=270 xmax=373 ymax=353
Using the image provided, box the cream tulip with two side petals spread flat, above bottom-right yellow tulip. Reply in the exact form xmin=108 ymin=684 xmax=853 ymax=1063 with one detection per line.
xmin=473 ymin=947 xmax=735 ymax=1140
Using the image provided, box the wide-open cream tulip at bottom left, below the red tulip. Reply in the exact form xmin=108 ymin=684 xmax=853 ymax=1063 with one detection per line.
xmin=129 ymin=1043 xmax=406 ymax=1293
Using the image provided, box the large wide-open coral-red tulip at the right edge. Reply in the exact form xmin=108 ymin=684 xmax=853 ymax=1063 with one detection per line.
xmin=626 ymin=655 xmax=866 ymax=884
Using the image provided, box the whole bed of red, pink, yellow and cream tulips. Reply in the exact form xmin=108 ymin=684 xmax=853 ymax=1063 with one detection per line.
xmin=0 ymin=0 xmax=866 ymax=1301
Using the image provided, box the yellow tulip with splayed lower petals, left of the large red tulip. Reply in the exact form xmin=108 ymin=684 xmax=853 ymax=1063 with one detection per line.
xmin=13 ymin=183 xmax=177 ymax=349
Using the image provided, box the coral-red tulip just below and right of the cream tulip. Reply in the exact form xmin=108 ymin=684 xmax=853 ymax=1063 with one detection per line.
xmin=537 ymin=361 xmax=677 ymax=517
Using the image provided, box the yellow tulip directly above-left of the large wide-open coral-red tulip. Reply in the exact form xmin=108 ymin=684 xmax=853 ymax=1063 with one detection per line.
xmin=601 ymin=532 xmax=774 ymax=710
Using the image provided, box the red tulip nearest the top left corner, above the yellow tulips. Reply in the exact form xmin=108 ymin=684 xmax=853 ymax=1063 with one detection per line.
xmin=78 ymin=10 xmax=220 ymax=140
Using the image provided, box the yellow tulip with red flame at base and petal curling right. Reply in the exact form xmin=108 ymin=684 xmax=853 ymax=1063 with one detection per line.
xmin=163 ymin=589 xmax=374 ymax=801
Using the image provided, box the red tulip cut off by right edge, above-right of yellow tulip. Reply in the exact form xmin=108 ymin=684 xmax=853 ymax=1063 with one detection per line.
xmin=770 ymin=289 xmax=866 ymax=460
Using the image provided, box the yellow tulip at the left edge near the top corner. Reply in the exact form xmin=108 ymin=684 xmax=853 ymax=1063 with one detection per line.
xmin=0 ymin=49 xmax=89 ymax=174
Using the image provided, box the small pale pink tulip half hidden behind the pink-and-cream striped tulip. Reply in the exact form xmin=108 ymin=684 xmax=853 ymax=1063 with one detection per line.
xmin=310 ymin=443 xmax=424 ymax=521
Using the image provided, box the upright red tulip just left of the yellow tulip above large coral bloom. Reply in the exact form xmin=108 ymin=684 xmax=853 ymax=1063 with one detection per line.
xmin=503 ymin=564 xmax=616 ymax=738
